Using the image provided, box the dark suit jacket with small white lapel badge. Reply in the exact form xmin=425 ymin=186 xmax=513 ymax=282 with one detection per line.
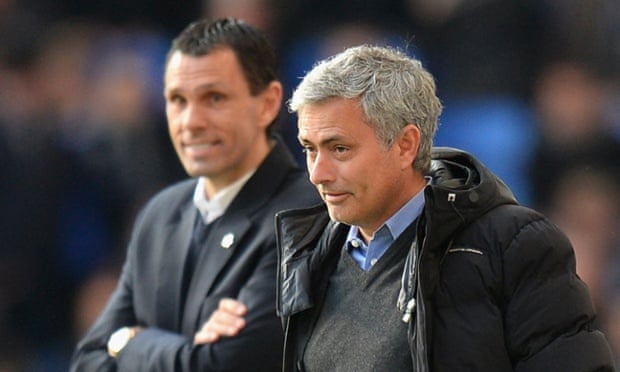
xmin=71 ymin=141 xmax=319 ymax=372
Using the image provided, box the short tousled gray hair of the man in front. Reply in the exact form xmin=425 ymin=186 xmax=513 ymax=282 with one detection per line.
xmin=288 ymin=45 xmax=442 ymax=174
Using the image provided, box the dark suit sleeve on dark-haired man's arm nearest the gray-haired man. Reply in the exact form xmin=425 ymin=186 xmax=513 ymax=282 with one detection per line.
xmin=118 ymin=241 xmax=283 ymax=372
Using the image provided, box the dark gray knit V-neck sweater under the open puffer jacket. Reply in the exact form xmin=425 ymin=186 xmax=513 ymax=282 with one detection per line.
xmin=303 ymin=235 xmax=412 ymax=372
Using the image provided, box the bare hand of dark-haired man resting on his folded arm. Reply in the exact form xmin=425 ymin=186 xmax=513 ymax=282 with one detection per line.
xmin=194 ymin=298 xmax=248 ymax=344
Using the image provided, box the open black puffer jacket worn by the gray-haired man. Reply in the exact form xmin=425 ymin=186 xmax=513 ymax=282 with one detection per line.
xmin=276 ymin=148 xmax=614 ymax=372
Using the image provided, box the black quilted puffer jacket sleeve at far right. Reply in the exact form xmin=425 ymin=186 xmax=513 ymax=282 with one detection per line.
xmin=504 ymin=218 xmax=614 ymax=372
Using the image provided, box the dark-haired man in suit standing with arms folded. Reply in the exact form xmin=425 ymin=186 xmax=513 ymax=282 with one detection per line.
xmin=71 ymin=18 xmax=319 ymax=372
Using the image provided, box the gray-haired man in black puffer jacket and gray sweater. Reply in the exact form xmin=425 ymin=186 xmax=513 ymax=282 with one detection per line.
xmin=209 ymin=46 xmax=614 ymax=372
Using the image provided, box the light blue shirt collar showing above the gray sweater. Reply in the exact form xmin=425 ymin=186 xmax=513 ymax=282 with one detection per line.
xmin=345 ymin=189 xmax=424 ymax=271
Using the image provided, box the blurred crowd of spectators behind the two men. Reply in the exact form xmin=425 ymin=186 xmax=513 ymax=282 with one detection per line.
xmin=0 ymin=0 xmax=620 ymax=372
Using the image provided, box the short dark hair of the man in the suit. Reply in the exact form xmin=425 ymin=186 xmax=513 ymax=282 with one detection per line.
xmin=166 ymin=18 xmax=277 ymax=95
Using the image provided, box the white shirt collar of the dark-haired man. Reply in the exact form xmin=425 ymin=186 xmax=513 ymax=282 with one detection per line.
xmin=194 ymin=170 xmax=255 ymax=223
